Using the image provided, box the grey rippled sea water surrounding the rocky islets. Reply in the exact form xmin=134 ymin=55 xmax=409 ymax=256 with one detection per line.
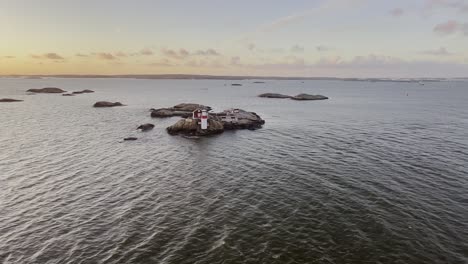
xmin=0 ymin=79 xmax=468 ymax=263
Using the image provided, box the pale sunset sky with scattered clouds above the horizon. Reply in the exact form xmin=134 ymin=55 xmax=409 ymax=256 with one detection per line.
xmin=0 ymin=0 xmax=468 ymax=78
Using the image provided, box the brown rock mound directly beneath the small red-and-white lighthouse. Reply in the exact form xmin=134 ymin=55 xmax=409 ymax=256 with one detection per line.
xmin=166 ymin=118 xmax=224 ymax=136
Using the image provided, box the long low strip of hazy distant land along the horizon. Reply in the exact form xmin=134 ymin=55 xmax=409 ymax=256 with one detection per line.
xmin=0 ymin=74 xmax=460 ymax=83
